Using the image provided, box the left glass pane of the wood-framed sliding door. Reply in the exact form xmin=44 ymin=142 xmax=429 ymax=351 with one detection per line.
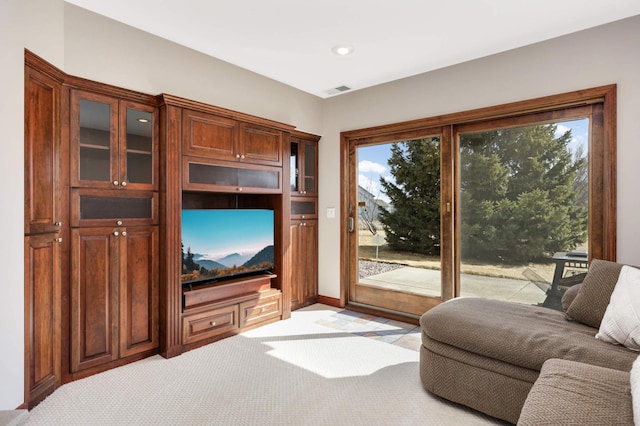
xmin=357 ymin=137 xmax=441 ymax=297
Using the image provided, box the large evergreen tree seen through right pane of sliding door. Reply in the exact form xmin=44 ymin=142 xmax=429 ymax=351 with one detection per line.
xmin=460 ymin=124 xmax=588 ymax=262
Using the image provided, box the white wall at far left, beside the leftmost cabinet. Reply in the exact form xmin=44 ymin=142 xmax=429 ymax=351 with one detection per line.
xmin=0 ymin=0 xmax=64 ymax=410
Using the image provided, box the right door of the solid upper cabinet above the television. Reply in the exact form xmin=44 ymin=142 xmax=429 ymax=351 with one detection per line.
xmin=240 ymin=124 xmax=282 ymax=166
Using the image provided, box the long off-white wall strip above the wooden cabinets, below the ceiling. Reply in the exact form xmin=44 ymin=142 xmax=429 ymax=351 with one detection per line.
xmin=65 ymin=4 xmax=323 ymax=134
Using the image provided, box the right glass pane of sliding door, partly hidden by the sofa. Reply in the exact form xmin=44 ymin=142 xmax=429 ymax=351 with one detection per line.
xmin=460 ymin=119 xmax=589 ymax=309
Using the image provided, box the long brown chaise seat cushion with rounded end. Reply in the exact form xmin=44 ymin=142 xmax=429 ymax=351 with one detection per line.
xmin=420 ymin=298 xmax=637 ymax=372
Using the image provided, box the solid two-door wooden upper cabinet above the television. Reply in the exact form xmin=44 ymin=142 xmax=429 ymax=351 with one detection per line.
xmin=182 ymin=109 xmax=283 ymax=166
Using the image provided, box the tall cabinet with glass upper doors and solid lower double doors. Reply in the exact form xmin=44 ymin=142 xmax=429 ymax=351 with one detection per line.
xmin=69 ymin=89 xmax=160 ymax=377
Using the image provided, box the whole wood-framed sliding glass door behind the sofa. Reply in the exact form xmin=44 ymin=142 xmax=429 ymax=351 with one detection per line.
xmin=342 ymin=86 xmax=616 ymax=316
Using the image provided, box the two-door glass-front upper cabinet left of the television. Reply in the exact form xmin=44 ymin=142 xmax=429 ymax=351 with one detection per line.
xmin=69 ymin=90 xmax=158 ymax=190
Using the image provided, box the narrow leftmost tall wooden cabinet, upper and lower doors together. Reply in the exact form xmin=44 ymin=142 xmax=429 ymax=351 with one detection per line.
xmin=24 ymin=57 xmax=68 ymax=408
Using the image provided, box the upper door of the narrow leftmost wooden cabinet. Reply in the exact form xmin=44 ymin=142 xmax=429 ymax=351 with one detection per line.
xmin=24 ymin=67 xmax=62 ymax=234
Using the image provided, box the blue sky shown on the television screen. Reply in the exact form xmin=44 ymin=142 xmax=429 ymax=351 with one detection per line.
xmin=182 ymin=210 xmax=273 ymax=260
